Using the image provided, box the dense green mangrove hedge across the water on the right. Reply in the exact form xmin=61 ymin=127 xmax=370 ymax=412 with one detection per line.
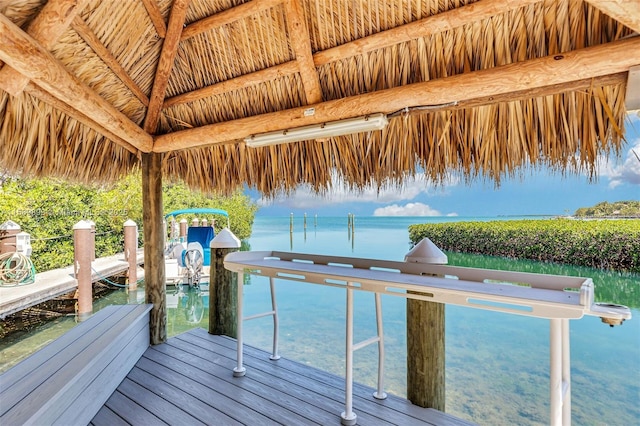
xmin=409 ymin=219 xmax=640 ymax=273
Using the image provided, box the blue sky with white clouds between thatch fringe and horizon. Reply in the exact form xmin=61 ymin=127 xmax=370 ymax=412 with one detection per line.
xmin=254 ymin=112 xmax=640 ymax=217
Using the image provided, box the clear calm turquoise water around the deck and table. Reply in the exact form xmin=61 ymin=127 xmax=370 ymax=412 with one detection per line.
xmin=0 ymin=216 xmax=640 ymax=425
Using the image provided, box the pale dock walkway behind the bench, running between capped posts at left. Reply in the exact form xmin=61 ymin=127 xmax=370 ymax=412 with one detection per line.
xmin=0 ymin=249 xmax=144 ymax=319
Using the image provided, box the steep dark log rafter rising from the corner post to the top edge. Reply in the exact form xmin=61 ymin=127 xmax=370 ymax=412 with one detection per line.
xmin=144 ymin=0 xmax=191 ymax=134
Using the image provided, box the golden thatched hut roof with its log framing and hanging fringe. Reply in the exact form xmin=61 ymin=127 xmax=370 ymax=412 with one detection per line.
xmin=0 ymin=0 xmax=640 ymax=194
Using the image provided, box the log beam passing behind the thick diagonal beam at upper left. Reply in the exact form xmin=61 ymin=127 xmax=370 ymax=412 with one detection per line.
xmin=0 ymin=0 xmax=88 ymax=96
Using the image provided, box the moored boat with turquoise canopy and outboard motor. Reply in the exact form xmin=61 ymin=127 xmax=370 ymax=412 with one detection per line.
xmin=164 ymin=208 xmax=229 ymax=289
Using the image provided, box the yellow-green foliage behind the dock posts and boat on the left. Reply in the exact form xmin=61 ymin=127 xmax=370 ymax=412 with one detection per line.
xmin=0 ymin=174 xmax=257 ymax=272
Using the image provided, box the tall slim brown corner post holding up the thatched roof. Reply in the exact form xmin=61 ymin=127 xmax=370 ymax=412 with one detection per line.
xmin=142 ymin=153 xmax=167 ymax=345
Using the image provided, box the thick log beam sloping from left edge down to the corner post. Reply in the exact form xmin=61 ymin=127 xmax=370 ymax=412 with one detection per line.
xmin=0 ymin=14 xmax=153 ymax=152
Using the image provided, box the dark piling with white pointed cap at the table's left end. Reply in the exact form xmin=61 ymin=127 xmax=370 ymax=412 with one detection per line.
xmin=209 ymin=228 xmax=240 ymax=338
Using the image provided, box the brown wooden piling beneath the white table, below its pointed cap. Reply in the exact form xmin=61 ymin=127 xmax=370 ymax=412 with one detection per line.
xmin=407 ymin=299 xmax=445 ymax=411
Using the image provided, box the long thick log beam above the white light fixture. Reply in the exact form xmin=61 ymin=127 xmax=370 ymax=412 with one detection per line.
xmin=153 ymin=37 xmax=640 ymax=152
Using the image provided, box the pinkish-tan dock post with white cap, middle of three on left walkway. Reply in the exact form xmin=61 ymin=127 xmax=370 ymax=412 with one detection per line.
xmin=73 ymin=220 xmax=95 ymax=321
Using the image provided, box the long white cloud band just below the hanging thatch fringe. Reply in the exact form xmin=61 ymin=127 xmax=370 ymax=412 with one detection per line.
xmin=258 ymin=174 xmax=460 ymax=209
